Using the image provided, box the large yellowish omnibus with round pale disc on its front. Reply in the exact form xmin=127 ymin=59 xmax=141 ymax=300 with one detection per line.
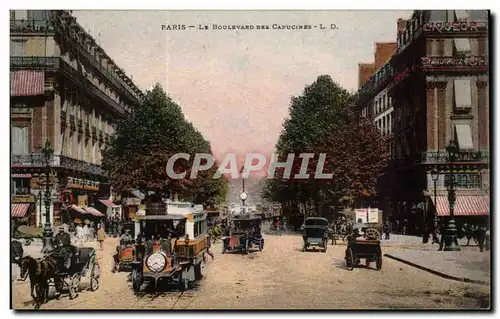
xmin=132 ymin=211 xmax=208 ymax=292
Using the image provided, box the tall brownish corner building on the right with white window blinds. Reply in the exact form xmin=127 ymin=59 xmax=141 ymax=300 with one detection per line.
xmin=358 ymin=10 xmax=490 ymax=233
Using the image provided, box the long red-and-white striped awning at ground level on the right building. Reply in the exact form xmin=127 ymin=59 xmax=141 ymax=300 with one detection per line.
xmin=431 ymin=195 xmax=490 ymax=216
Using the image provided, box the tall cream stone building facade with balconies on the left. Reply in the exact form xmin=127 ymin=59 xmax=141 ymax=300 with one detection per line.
xmin=10 ymin=10 xmax=143 ymax=226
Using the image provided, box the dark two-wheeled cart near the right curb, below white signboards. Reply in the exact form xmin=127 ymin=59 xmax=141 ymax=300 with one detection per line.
xmin=345 ymin=236 xmax=382 ymax=270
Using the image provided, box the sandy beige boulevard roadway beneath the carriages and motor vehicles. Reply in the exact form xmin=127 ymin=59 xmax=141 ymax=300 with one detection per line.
xmin=13 ymin=234 xmax=489 ymax=309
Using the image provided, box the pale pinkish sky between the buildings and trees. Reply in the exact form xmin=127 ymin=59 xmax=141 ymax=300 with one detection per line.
xmin=73 ymin=11 xmax=412 ymax=162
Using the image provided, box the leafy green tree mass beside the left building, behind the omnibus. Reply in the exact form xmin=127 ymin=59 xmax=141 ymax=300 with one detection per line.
xmin=102 ymin=84 xmax=227 ymax=205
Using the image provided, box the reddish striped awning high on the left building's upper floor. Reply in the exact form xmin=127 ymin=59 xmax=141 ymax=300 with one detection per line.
xmin=10 ymin=70 xmax=45 ymax=96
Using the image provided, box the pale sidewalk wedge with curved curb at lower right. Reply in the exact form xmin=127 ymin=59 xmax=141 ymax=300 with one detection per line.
xmin=384 ymin=249 xmax=491 ymax=285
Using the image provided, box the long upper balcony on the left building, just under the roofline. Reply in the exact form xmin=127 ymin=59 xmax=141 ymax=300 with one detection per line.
xmin=10 ymin=57 xmax=127 ymax=117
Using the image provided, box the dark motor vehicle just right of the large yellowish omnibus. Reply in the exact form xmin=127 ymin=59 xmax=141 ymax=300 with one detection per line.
xmin=222 ymin=214 xmax=264 ymax=254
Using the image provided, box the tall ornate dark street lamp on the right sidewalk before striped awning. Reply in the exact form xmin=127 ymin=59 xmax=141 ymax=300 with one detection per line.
xmin=444 ymin=140 xmax=460 ymax=251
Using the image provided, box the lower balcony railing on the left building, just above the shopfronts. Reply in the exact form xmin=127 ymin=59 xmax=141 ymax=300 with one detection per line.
xmin=10 ymin=153 xmax=106 ymax=176
